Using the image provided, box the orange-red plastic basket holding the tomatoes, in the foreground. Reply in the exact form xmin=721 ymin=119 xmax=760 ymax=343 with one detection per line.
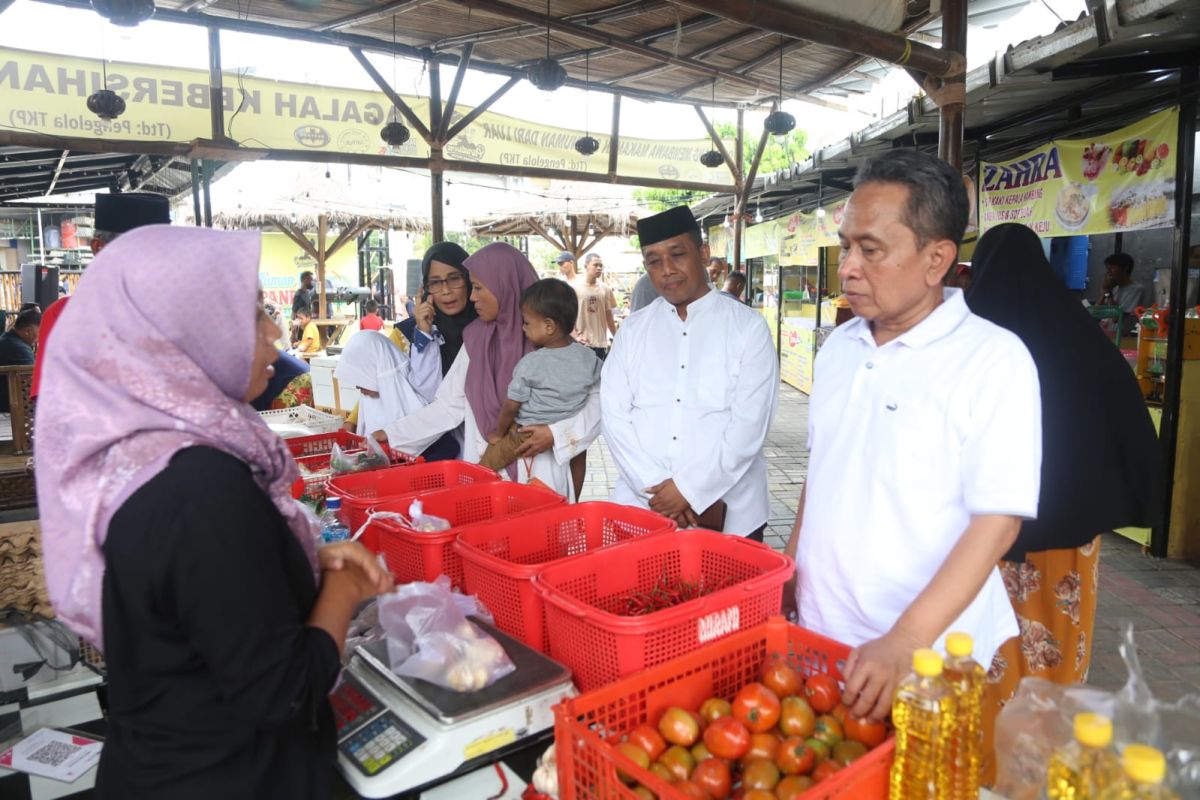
xmin=554 ymin=618 xmax=895 ymax=800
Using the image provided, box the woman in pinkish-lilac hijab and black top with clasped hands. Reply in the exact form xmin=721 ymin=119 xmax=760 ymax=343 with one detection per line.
xmin=36 ymin=225 xmax=390 ymax=800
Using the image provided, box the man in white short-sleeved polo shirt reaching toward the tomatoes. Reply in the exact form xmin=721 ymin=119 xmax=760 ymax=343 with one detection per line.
xmin=787 ymin=150 xmax=1042 ymax=720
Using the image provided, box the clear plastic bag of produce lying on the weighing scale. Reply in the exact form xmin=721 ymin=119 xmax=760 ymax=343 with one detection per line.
xmin=379 ymin=576 xmax=506 ymax=692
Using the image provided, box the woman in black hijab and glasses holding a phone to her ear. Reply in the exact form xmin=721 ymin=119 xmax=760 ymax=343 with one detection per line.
xmin=392 ymin=241 xmax=475 ymax=461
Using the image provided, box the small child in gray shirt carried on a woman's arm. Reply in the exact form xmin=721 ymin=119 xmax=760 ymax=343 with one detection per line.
xmin=479 ymin=278 xmax=601 ymax=470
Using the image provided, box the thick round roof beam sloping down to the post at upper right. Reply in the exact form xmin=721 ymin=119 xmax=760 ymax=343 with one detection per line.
xmin=680 ymin=0 xmax=966 ymax=78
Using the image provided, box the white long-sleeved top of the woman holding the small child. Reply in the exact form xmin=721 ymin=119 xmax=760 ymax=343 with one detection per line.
xmin=384 ymin=348 xmax=600 ymax=500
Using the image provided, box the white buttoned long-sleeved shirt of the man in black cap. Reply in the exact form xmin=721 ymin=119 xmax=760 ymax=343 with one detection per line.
xmin=600 ymin=290 xmax=779 ymax=536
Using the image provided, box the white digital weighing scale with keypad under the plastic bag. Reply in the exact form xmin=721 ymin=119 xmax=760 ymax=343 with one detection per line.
xmin=330 ymin=619 xmax=575 ymax=798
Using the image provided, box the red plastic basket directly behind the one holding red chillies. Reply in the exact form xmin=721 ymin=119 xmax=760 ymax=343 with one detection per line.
xmin=455 ymin=503 xmax=676 ymax=652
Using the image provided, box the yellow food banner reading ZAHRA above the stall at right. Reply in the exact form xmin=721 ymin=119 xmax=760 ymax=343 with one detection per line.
xmin=979 ymin=108 xmax=1180 ymax=236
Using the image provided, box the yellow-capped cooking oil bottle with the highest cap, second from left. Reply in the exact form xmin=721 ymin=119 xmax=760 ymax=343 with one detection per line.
xmin=942 ymin=633 xmax=988 ymax=800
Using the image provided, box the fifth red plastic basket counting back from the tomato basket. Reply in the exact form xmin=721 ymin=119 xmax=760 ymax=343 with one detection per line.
xmin=325 ymin=461 xmax=500 ymax=533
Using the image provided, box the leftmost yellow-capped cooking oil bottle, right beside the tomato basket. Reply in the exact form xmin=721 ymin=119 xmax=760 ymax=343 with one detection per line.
xmin=889 ymin=650 xmax=955 ymax=800
